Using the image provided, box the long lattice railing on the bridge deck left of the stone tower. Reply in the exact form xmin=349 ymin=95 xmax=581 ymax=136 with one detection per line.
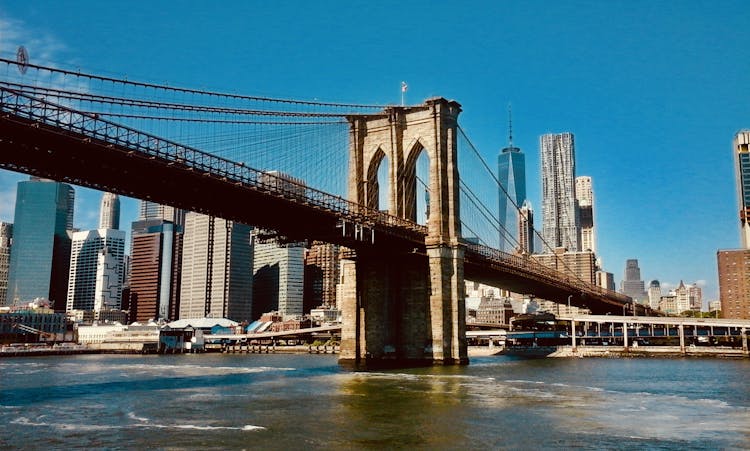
xmin=0 ymin=87 xmax=426 ymax=238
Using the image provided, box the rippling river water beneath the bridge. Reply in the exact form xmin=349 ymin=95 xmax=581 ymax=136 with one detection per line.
xmin=0 ymin=354 xmax=750 ymax=450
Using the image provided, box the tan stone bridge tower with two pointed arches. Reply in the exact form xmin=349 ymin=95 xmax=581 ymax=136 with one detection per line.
xmin=340 ymin=98 xmax=468 ymax=367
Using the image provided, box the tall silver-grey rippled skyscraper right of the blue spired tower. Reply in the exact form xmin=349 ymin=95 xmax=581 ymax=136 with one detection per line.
xmin=539 ymin=133 xmax=581 ymax=252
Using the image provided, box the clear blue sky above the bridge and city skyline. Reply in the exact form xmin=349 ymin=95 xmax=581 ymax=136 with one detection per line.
xmin=0 ymin=0 xmax=750 ymax=299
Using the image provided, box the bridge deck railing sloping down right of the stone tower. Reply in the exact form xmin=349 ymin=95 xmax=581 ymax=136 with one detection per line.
xmin=465 ymin=243 xmax=631 ymax=303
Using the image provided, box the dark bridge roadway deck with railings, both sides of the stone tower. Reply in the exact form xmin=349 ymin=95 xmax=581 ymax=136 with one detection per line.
xmin=0 ymin=87 xmax=652 ymax=314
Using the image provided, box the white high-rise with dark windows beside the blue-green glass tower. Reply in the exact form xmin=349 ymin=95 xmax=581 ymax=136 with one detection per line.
xmin=66 ymin=229 xmax=125 ymax=311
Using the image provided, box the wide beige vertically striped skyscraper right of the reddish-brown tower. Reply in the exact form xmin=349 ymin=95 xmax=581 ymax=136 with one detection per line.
xmin=180 ymin=212 xmax=254 ymax=322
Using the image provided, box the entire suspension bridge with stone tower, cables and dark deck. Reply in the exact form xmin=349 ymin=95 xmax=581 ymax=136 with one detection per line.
xmin=0 ymin=59 xmax=652 ymax=366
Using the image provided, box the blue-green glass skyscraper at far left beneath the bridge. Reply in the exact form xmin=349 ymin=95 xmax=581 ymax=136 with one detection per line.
xmin=6 ymin=177 xmax=75 ymax=311
